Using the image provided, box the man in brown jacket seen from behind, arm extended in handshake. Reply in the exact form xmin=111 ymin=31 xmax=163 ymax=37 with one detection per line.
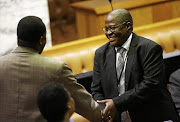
xmin=0 ymin=16 xmax=101 ymax=122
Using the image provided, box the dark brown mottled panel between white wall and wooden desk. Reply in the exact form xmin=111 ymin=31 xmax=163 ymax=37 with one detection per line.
xmin=48 ymin=0 xmax=85 ymax=45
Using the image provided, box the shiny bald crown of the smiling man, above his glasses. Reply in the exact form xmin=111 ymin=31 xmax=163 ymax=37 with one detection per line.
xmin=106 ymin=8 xmax=133 ymax=25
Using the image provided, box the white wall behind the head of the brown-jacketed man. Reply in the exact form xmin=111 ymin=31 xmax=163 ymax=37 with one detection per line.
xmin=0 ymin=0 xmax=52 ymax=56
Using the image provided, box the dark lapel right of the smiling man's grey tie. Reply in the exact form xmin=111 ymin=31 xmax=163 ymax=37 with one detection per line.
xmin=125 ymin=33 xmax=138 ymax=90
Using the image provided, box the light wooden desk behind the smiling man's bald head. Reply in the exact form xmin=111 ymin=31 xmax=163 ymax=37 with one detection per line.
xmin=71 ymin=0 xmax=180 ymax=39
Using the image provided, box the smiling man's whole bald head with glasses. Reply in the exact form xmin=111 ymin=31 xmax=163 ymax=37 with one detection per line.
xmin=104 ymin=9 xmax=133 ymax=47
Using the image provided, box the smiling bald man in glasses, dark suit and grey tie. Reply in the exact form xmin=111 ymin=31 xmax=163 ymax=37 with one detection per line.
xmin=91 ymin=9 xmax=180 ymax=122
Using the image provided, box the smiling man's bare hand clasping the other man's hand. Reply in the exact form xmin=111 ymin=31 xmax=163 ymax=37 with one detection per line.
xmin=97 ymin=99 xmax=117 ymax=122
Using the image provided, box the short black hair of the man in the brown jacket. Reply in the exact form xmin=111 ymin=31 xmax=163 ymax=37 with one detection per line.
xmin=17 ymin=16 xmax=46 ymax=43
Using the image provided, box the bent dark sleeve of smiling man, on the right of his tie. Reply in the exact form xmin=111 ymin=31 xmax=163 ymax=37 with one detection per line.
xmin=113 ymin=44 xmax=165 ymax=112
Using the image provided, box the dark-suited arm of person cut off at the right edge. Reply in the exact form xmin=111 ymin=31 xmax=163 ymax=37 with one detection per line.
xmin=169 ymin=69 xmax=180 ymax=116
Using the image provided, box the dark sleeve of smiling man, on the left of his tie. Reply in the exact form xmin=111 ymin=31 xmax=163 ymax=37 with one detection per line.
xmin=91 ymin=50 xmax=105 ymax=109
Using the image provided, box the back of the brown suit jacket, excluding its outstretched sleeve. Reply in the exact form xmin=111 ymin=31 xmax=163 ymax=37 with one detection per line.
xmin=0 ymin=48 xmax=68 ymax=121
